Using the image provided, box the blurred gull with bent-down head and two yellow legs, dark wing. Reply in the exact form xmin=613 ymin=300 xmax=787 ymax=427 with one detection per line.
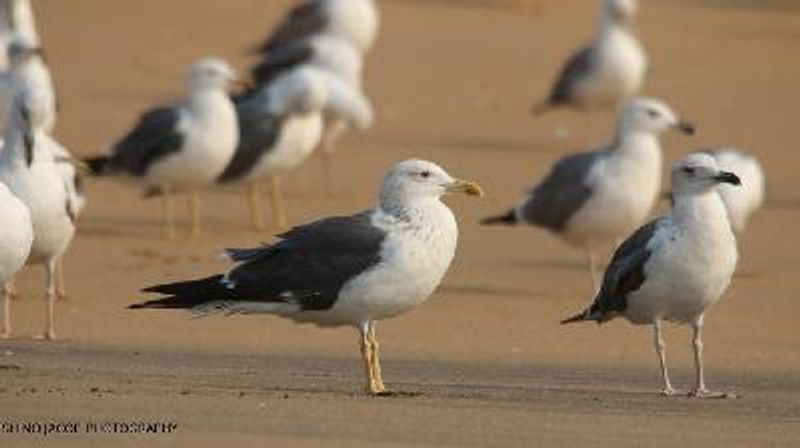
xmin=219 ymin=66 xmax=370 ymax=230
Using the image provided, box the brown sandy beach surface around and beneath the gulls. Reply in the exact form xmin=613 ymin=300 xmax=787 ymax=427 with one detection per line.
xmin=0 ymin=0 xmax=800 ymax=447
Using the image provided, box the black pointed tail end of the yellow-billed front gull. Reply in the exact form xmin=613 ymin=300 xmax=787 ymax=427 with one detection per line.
xmin=128 ymin=275 xmax=232 ymax=310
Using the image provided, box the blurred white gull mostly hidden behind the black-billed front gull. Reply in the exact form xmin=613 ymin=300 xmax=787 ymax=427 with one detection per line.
xmin=708 ymin=148 xmax=766 ymax=235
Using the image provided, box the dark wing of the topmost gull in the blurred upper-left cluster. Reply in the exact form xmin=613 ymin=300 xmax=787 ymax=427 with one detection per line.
xmin=258 ymin=0 xmax=328 ymax=55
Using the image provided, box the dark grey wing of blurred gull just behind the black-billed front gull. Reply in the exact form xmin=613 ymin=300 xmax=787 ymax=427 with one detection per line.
xmin=521 ymin=151 xmax=606 ymax=232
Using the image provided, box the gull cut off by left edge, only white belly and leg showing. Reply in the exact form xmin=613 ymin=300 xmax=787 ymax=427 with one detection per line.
xmin=0 ymin=182 xmax=33 ymax=339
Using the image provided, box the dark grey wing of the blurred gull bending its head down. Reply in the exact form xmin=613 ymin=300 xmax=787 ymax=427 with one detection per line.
xmin=219 ymin=93 xmax=283 ymax=183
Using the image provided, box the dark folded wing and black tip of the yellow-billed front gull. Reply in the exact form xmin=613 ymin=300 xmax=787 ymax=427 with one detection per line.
xmin=133 ymin=212 xmax=386 ymax=311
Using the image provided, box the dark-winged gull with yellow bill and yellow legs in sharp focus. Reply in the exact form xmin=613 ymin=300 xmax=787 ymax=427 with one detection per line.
xmin=131 ymin=160 xmax=482 ymax=394
